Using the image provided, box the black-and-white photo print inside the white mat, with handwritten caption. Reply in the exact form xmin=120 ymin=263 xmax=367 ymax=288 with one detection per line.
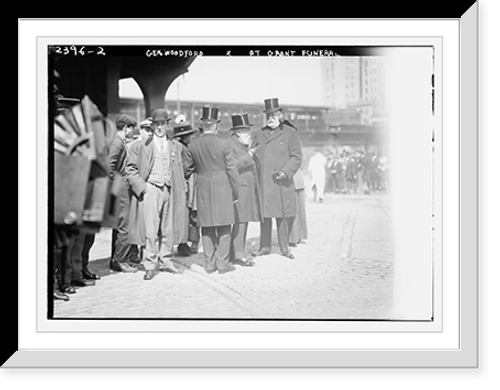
xmin=46 ymin=42 xmax=440 ymax=322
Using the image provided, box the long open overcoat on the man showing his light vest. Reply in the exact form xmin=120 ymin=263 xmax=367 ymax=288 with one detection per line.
xmin=125 ymin=136 xmax=193 ymax=245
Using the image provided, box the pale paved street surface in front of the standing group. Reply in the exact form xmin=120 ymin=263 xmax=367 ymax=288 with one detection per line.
xmin=54 ymin=194 xmax=393 ymax=319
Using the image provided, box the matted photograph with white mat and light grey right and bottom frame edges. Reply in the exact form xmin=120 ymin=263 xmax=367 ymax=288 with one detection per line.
xmin=13 ymin=14 xmax=479 ymax=369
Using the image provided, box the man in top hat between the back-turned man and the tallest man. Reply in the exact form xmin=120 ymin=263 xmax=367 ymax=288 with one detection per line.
xmin=229 ymin=114 xmax=261 ymax=267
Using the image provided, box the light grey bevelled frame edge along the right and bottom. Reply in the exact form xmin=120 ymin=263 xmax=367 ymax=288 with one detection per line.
xmin=10 ymin=9 xmax=478 ymax=368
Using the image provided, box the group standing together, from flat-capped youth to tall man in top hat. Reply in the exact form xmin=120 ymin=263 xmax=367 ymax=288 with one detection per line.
xmin=102 ymin=98 xmax=302 ymax=280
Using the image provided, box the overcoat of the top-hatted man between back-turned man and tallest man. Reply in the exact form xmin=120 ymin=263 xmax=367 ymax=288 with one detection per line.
xmin=229 ymin=133 xmax=261 ymax=223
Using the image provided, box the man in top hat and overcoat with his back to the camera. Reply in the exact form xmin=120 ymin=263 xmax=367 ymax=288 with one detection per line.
xmin=189 ymin=106 xmax=238 ymax=274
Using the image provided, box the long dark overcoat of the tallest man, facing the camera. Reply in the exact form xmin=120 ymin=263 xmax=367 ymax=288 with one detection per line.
xmin=255 ymin=123 xmax=302 ymax=218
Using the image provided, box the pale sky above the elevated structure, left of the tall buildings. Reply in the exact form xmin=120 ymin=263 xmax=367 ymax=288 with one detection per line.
xmin=119 ymin=56 xmax=322 ymax=106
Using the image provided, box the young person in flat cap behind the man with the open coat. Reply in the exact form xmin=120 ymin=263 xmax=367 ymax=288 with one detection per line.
xmin=108 ymin=114 xmax=137 ymax=272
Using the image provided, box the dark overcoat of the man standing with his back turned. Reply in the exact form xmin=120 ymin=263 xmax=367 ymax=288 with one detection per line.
xmin=188 ymin=134 xmax=238 ymax=227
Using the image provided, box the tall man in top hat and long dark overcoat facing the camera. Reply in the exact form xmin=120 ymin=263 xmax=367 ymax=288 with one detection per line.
xmin=255 ymin=98 xmax=302 ymax=259
